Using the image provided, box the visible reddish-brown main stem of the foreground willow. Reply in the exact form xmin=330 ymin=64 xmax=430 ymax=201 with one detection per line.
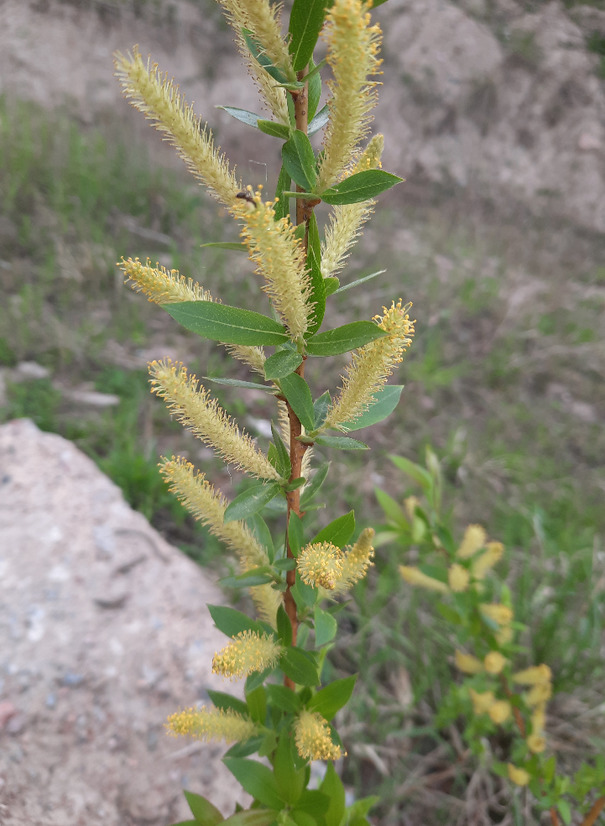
xmin=284 ymin=69 xmax=313 ymax=690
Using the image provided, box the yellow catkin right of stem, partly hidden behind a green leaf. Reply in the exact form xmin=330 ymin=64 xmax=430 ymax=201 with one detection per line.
xmin=321 ymin=135 xmax=384 ymax=278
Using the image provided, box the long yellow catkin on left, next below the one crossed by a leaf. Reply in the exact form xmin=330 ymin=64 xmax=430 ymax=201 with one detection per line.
xmin=149 ymin=359 xmax=281 ymax=481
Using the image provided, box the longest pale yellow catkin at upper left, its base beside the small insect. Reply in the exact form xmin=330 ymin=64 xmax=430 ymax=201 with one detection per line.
xmin=115 ymin=46 xmax=241 ymax=207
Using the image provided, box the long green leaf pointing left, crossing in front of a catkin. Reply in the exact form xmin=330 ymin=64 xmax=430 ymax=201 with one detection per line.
xmin=162 ymin=301 xmax=288 ymax=345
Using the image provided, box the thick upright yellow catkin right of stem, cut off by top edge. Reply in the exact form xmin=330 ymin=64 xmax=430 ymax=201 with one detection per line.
xmin=317 ymin=0 xmax=382 ymax=192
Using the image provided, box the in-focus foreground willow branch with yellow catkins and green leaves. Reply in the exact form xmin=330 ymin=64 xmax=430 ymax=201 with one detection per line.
xmin=115 ymin=0 xmax=414 ymax=826
